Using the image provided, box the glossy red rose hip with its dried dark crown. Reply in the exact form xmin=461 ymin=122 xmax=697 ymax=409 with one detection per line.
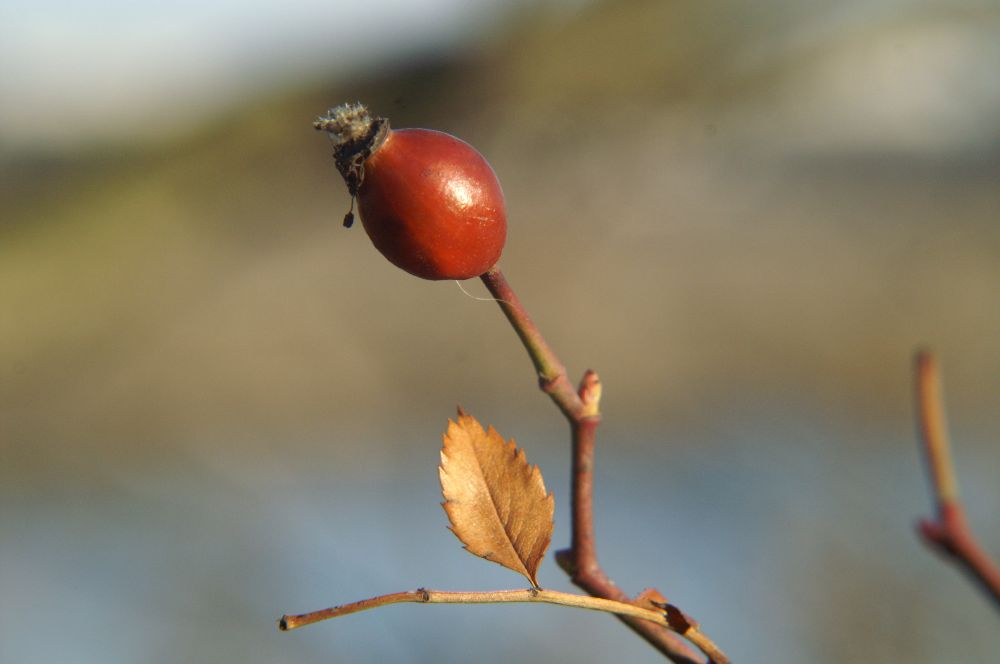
xmin=314 ymin=104 xmax=507 ymax=279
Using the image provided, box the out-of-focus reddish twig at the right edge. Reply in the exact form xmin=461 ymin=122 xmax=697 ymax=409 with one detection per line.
xmin=915 ymin=351 xmax=1000 ymax=609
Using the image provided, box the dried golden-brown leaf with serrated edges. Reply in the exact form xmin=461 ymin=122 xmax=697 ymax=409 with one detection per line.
xmin=439 ymin=409 xmax=555 ymax=588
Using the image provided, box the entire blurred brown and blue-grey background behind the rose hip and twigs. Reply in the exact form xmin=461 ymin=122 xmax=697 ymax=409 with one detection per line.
xmin=0 ymin=0 xmax=1000 ymax=664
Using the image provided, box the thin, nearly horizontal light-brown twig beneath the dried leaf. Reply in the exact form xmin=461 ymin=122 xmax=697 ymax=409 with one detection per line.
xmin=278 ymin=588 xmax=723 ymax=661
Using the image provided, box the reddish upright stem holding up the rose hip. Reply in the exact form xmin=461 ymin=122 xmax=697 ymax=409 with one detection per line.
xmin=480 ymin=268 xmax=729 ymax=664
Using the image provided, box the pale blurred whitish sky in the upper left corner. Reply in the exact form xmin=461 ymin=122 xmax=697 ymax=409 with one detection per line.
xmin=0 ymin=0 xmax=581 ymax=147
